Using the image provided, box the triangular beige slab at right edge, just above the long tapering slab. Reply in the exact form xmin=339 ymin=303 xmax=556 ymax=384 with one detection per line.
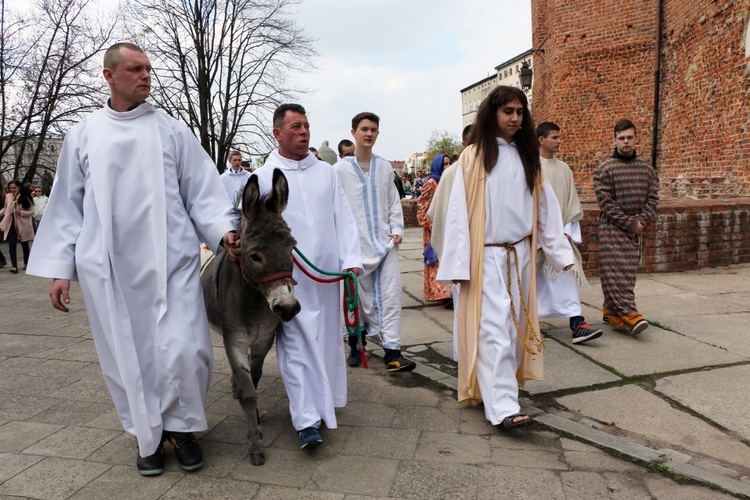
xmin=656 ymin=365 xmax=750 ymax=442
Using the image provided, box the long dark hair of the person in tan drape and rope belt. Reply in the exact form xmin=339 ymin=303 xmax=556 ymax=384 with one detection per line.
xmin=467 ymin=86 xmax=542 ymax=192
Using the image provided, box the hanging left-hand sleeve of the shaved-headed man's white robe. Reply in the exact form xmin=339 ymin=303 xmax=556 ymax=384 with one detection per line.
xmin=27 ymin=128 xmax=85 ymax=280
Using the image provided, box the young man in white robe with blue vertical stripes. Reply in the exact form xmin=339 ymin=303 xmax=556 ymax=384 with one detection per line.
xmin=333 ymin=112 xmax=417 ymax=372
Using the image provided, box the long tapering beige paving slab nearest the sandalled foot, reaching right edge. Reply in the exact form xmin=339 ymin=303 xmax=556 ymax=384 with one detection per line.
xmin=558 ymin=385 xmax=750 ymax=467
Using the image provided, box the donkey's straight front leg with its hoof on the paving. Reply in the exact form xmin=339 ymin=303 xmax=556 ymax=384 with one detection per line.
xmin=224 ymin=330 xmax=266 ymax=465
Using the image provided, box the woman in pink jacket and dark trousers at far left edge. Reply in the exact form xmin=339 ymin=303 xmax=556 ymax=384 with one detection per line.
xmin=0 ymin=180 xmax=34 ymax=274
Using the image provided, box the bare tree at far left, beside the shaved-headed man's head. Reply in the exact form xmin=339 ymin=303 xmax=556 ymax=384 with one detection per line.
xmin=2 ymin=0 xmax=116 ymax=183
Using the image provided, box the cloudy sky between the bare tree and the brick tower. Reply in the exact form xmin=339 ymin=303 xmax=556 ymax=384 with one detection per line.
xmin=294 ymin=0 xmax=531 ymax=160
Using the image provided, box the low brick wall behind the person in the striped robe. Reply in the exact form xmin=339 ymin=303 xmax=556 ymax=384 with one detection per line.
xmin=578 ymin=197 xmax=750 ymax=276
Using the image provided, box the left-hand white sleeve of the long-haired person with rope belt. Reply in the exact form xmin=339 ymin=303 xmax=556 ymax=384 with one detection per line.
xmin=437 ymin=165 xmax=471 ymax=283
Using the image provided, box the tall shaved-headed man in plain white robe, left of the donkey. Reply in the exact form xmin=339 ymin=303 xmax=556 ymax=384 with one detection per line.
xmin=28 ymin=43 xmax=238 ymax=475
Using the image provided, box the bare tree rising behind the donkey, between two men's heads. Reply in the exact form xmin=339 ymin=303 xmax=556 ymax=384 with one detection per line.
xmin=134 ymin=0 xmax=314 ymax=172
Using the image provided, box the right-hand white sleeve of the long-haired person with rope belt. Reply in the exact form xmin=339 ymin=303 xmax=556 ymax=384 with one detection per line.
xmin=537 ymin=179 xmax=575 ymax=271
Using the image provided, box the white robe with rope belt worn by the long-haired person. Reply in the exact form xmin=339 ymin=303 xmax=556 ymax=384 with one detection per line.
xmin=437 ymin=139 xmax=574 ymax=425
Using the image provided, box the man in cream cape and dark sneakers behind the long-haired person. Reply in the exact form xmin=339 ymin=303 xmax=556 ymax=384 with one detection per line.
xmin=536 ymin=122 xmax=602 ymax=344
